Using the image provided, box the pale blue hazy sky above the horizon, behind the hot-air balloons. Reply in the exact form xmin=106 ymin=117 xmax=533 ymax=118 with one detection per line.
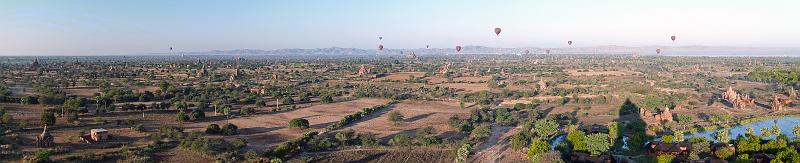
xmin=0 ymin=0 xmax=800 ymax=55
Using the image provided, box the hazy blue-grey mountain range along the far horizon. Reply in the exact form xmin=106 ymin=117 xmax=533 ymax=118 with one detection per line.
xmin=148 ymin=45 xmax=800 ymax=56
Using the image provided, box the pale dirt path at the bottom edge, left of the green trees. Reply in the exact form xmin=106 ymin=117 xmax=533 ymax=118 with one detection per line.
xmin=470 ymin=124 xmax=520 ymax=162
